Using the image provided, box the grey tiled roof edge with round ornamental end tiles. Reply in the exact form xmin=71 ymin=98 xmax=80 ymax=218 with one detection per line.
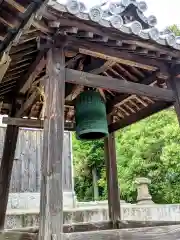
xmin=48 ymin=0 xmax=180 ymax=50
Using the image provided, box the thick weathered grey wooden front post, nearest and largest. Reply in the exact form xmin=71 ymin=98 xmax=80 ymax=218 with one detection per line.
xmin=39 ymin=49 xmax=65 ymax=240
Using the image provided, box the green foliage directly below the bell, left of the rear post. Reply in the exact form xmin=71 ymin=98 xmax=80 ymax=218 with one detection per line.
xmin=73 ymin=135 xmax=104 ymax=201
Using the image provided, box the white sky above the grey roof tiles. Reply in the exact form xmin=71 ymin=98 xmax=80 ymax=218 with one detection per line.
xmin=84 ymin=0 xmax=180 ymax=30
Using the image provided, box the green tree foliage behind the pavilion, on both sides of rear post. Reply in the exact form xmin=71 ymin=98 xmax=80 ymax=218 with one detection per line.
xmin=73 ymin=25 xmax=180 ymax=203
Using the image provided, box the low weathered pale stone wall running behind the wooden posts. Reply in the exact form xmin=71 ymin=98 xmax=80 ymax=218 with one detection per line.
xmin=5 ymin=204 xmax=180 ymax=229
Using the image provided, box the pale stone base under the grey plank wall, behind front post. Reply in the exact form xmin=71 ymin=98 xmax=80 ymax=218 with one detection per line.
xmin=7 ymin=192 xmax=76 ymax=210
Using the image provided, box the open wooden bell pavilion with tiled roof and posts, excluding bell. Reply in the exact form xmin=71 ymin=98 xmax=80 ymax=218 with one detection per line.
xmin=0 ymin=0 xmax=180 ymax=240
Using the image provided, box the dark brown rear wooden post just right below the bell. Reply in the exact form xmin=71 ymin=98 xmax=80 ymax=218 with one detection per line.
xmin=104 ymin=133 xmax=121 ymax=228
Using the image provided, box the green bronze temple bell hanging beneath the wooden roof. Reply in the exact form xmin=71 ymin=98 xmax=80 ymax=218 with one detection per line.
xmin=75 ymin=90 xmax=108 ymax=140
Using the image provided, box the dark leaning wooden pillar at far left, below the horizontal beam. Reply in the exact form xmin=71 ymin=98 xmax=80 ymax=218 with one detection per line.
xmin=0 ymin=125 xmax=19 ymax=230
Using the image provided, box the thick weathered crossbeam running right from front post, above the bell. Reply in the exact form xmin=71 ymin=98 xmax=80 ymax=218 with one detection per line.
xmin=66 ymin=69 xmax=174 ymax=102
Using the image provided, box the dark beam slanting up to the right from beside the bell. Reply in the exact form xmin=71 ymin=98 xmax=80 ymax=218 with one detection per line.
xmin=109 ymin=102 xmax=172 ymax=132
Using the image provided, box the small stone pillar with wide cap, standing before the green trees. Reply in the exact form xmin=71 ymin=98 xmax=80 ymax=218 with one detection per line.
xmin=135 ymin=178 xmax=153 ymax=204
